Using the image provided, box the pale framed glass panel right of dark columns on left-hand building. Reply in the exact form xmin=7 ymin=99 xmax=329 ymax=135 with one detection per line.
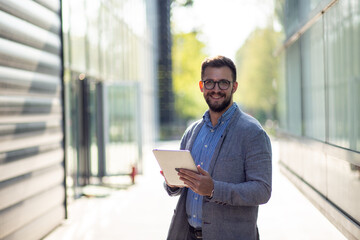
xmin=106 ymin=83 xmax=141 ymax=175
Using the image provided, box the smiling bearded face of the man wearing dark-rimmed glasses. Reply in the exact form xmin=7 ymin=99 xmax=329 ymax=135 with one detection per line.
xmin=200 ymin=67 xmax=238 ymax=113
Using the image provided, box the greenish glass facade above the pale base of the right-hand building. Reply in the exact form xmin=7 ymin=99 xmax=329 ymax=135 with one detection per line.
xmin=279 ymin=0 xmax=360 ymax=151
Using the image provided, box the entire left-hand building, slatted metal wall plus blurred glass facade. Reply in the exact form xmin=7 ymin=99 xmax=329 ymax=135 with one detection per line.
xmin=0 ymin=0 xmax=158 ymax=240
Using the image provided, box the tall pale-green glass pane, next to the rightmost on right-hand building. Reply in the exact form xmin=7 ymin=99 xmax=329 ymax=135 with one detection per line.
xmin=325 ymin=1 xmax=351 ymax=148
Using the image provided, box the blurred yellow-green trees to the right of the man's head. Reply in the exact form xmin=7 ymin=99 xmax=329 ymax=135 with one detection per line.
xmin=234 ymin=27 xmax=280 ymax=123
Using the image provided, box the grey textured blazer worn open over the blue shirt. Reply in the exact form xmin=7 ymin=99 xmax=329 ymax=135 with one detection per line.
xmin=164 ymin=108 xmax=272 ymax=240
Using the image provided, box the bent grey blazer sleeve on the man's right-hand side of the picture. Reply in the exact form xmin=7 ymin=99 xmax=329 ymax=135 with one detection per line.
xmin=210 ymin=130 xmax=272 ymax=206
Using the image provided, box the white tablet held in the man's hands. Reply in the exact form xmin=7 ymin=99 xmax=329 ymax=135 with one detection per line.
xmin=153 ymin=149 xmax=198 ymax=186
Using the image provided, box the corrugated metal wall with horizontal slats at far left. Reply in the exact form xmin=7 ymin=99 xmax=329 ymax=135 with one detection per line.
xmin=0 ymin=0 xmax=65 ymax=240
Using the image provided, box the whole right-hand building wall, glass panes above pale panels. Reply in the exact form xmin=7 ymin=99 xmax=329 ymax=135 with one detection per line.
xmin=278 ymin=0 xmax=360 ymax=239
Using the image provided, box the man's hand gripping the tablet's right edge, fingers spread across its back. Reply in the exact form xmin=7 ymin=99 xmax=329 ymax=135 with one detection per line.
xmin=178 ymin=165 xmax=214 ymax=196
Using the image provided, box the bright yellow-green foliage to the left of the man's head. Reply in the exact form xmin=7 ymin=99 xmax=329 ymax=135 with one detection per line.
xmin=172 ymin=32 xmax=207 ymax=121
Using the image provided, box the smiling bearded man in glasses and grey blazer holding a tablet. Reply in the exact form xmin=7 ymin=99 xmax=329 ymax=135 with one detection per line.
xmin=165 ymin=56 xmax=271 ymax=240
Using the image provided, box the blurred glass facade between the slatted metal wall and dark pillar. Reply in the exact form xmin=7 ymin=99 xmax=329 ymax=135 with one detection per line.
xmin=62 ymin=0 xmax=158 ymax=197
